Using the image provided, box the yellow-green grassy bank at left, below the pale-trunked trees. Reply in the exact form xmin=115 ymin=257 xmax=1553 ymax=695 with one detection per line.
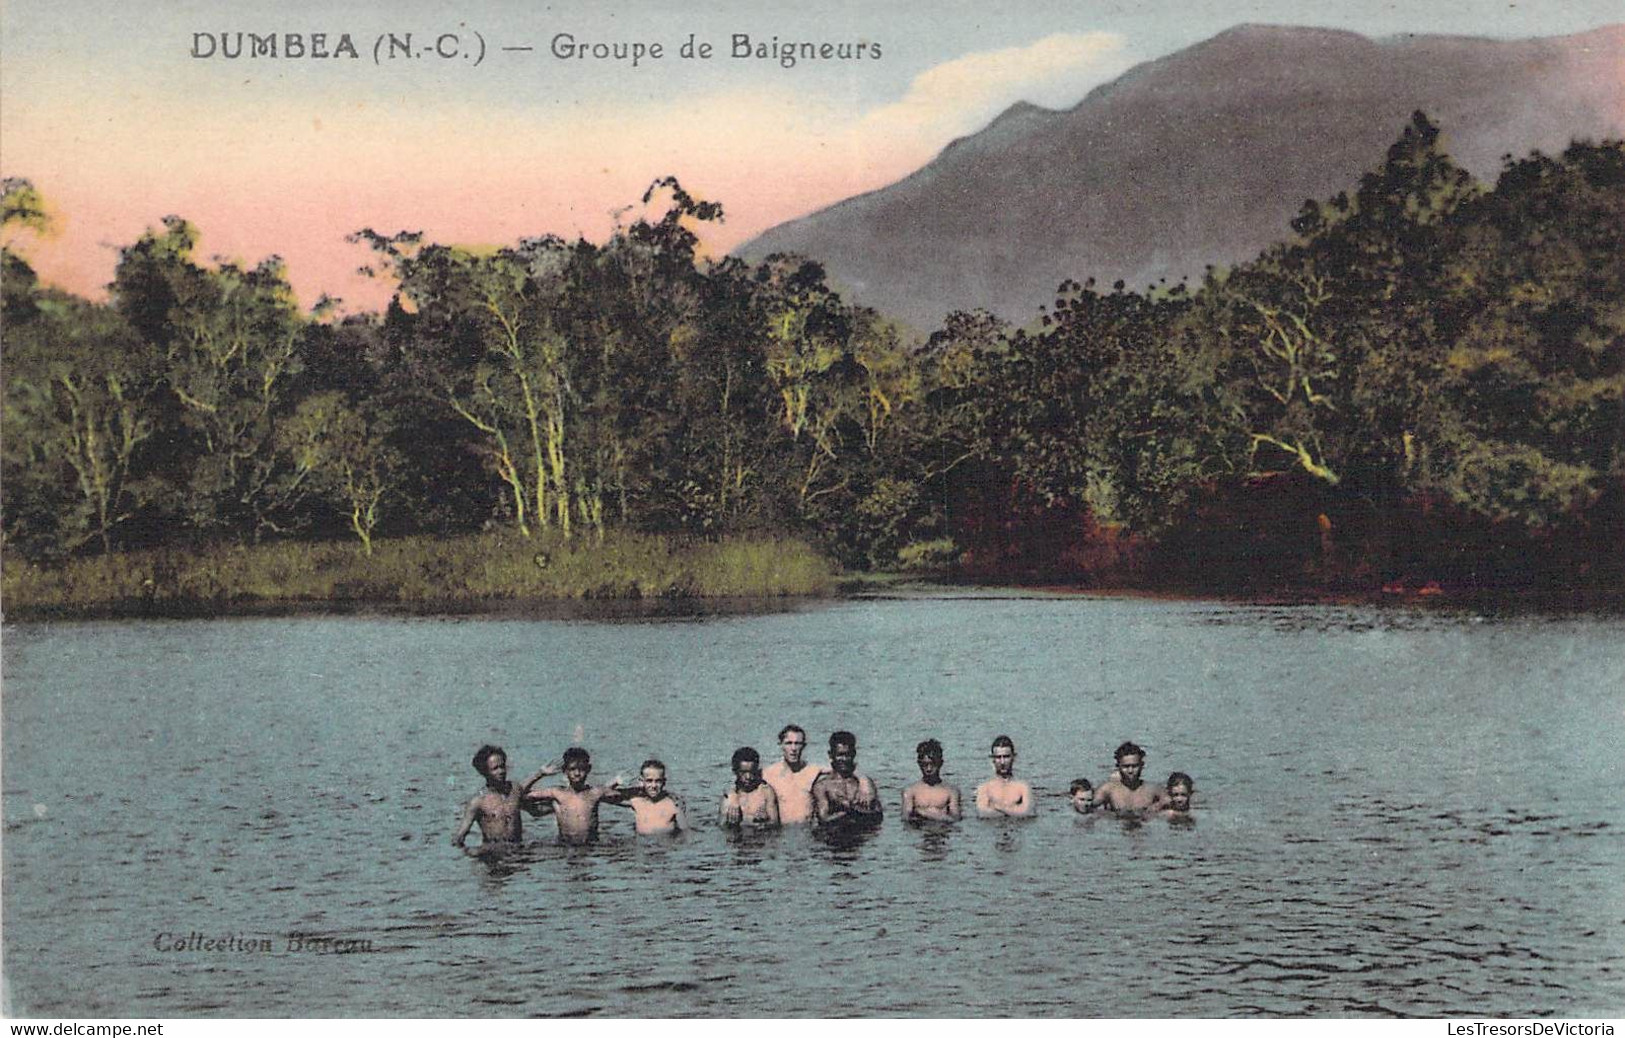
xmin=0 ymin=533 xmax=837 ymax=619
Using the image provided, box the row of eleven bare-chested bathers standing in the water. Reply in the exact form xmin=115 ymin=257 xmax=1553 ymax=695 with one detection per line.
xmin=452 ymin=724 xmax=1196 ymax=846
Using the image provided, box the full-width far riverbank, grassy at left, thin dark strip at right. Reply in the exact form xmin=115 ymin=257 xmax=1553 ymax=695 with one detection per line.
xmin=9 ymin=531 xmax=1625 ymax=622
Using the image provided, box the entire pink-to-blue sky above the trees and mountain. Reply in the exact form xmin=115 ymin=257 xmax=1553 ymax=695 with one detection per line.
xmin=0 ymin=0 xmax=1622 ymax=310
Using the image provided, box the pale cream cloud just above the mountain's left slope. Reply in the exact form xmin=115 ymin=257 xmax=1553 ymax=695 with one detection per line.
xmin=863 ymin=32 xmax=1131 ymax=146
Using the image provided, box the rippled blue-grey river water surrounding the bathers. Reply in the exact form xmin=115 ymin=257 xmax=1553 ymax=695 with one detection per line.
xmin=3 ymin=596 xmax=1625 ymax=1017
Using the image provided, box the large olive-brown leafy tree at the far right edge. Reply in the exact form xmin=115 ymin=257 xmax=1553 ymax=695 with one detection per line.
xmin=1419 ymin=141 xmax=1625 ymax=526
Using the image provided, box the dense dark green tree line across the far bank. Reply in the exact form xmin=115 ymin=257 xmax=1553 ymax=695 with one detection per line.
xmin=3 ymin=114 xmax=1625 ymax=585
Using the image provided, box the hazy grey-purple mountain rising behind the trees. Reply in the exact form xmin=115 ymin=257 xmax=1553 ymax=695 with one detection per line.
xmin=738 ymin=26 xmax=1625 ymax=330
